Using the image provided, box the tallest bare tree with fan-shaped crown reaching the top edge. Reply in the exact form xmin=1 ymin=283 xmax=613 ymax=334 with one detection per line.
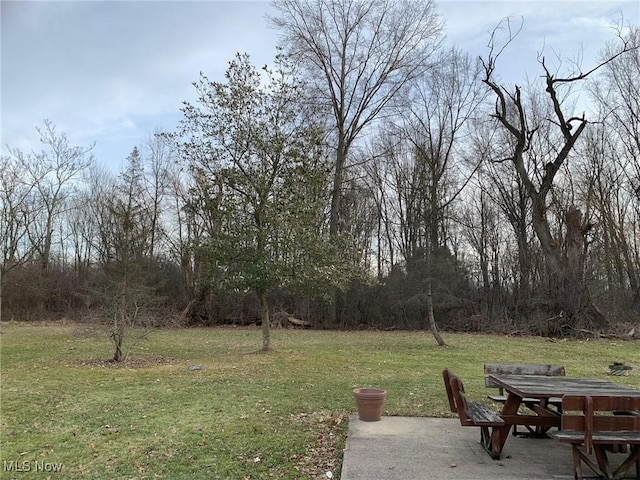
xmin=271 ymin=0 xmax=442 ymax=236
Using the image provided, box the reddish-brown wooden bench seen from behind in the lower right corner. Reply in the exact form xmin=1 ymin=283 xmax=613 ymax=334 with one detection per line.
xmin=553 ymin=395 xmax=640 ymax=480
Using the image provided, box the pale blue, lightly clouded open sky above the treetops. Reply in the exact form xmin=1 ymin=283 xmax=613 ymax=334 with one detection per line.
xmin=0 ymin=0 xmax=640 ymax=171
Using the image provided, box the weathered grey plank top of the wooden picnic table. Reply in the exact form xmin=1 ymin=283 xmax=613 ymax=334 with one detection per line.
xmin=489 ymin=374 xmax=640 ymax=398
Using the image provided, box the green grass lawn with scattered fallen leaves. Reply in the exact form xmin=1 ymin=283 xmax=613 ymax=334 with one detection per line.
xmin=0 ymin=323 xmax=640 ymax=479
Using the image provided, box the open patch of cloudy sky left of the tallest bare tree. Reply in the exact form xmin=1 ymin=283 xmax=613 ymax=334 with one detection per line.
xmin=2 ymin=1 xmax=275 ymax=164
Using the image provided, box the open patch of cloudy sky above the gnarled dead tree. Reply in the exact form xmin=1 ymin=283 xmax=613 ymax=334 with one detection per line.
xmin=439 ymin=0 xmax=640 ymax=84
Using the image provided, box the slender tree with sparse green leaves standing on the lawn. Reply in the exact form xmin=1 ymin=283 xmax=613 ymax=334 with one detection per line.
xmin=179 ymin=54 xmax=340 ymax=351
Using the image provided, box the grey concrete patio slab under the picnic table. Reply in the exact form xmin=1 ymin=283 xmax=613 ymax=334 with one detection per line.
xmin=341 ymin=415 xmax=636 ymax=480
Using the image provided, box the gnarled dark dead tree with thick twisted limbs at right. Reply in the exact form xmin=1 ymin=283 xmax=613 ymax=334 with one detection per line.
xmin=483 ymin=21 xmax=637 ymax=334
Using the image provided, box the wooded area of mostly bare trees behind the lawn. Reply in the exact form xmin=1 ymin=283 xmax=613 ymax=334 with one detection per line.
xmin=0 ymin=0 xmax=640 ymax=357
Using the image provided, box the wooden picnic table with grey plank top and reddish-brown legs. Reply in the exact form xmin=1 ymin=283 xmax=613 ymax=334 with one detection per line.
xmin=489 ymin=374 xmax=640 ymax=459
